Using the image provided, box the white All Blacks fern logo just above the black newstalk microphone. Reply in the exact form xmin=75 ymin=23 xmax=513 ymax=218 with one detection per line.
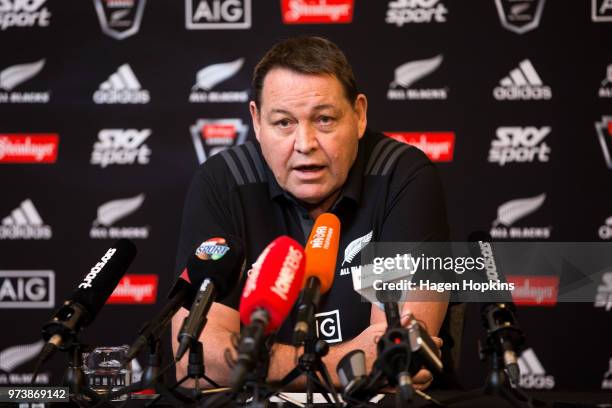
xmin=89 ymin=194 xmax=149 ymax=239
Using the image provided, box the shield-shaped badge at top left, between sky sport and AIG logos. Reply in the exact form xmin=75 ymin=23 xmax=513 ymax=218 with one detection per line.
xmin=94 ymin=0 xmax=147 ymax=40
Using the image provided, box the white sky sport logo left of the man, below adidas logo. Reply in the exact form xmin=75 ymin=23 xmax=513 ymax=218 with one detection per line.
xmin=90 ymin=129 xmax=151 ymax=168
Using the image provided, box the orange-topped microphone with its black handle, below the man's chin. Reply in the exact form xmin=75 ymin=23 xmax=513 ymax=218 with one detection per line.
xmin=293 ymin=213 xmax=340 ymax=345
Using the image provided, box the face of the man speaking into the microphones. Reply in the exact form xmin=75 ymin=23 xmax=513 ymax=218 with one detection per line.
xmin=250 ymin=68 xmax=367 ymax=205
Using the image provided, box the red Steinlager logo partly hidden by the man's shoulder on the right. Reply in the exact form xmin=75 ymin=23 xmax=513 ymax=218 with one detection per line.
xmin=385 ymin=132 xmax=455 ymax=162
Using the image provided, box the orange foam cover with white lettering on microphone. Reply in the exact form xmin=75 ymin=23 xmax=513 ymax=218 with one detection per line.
xmin=304 ymin=213 xmax=340 ymax=293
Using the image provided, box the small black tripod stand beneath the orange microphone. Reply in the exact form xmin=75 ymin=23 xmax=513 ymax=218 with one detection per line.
xmin=280 ymin=313 xmax=342 ymax=407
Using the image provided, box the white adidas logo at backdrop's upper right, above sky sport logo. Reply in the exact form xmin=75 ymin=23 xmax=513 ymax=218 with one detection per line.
xmin=493 ymin=59 xmax=552 ymax=101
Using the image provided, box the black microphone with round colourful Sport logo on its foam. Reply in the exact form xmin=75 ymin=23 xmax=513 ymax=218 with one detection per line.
xmin=176 ymin=238 xmax=245 ymax=361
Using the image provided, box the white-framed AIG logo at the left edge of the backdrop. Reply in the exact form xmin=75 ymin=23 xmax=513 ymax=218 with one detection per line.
xmin=0 ymin=271 xmax=55 ymax=309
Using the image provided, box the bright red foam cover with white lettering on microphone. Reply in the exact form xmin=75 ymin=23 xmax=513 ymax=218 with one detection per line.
xmin=240 ymin=236 xmax=305 ymax=334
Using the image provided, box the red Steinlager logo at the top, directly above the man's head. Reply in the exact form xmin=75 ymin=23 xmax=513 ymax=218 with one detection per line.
xmin=281 ymin=0 xmax=355 ymax=24
